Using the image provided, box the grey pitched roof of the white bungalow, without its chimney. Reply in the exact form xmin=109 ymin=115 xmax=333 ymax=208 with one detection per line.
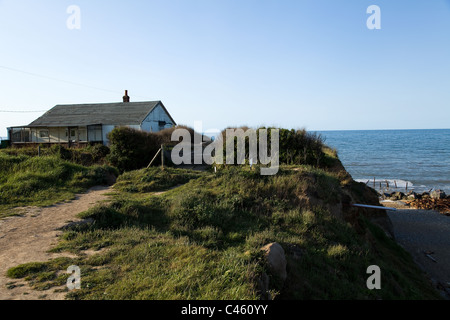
xmin=28 ymin=101 xmax=175 ymax=127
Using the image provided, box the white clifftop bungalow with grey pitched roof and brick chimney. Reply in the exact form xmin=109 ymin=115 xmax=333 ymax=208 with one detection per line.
xmin=8 ymin=91 xmax=176 ymax=145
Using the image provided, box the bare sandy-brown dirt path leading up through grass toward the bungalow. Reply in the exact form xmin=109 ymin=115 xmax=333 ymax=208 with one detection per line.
xmin=0 ymin=187 xmax=110 ymax=300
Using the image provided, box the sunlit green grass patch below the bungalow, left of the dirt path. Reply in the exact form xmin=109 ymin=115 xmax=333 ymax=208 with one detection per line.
xmin=0 ymin=153 xmax=118 ymax=218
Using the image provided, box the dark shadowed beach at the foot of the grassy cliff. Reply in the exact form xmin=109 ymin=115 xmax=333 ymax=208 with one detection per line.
xmin=388 ymin=209 xmax=450 ymax=299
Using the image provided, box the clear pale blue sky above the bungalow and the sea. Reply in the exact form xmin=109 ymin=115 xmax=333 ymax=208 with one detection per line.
xmin=0 ymin=0 xmax=450 ymax=136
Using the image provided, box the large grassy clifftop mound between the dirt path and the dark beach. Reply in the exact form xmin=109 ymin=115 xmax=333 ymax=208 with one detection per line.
xmin=7 ymin=166 xmax=439 ymax=299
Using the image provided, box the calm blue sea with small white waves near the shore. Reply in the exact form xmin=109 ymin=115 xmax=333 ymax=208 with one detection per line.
xmin=319 ymin=129 xmax=450 ymax=194
